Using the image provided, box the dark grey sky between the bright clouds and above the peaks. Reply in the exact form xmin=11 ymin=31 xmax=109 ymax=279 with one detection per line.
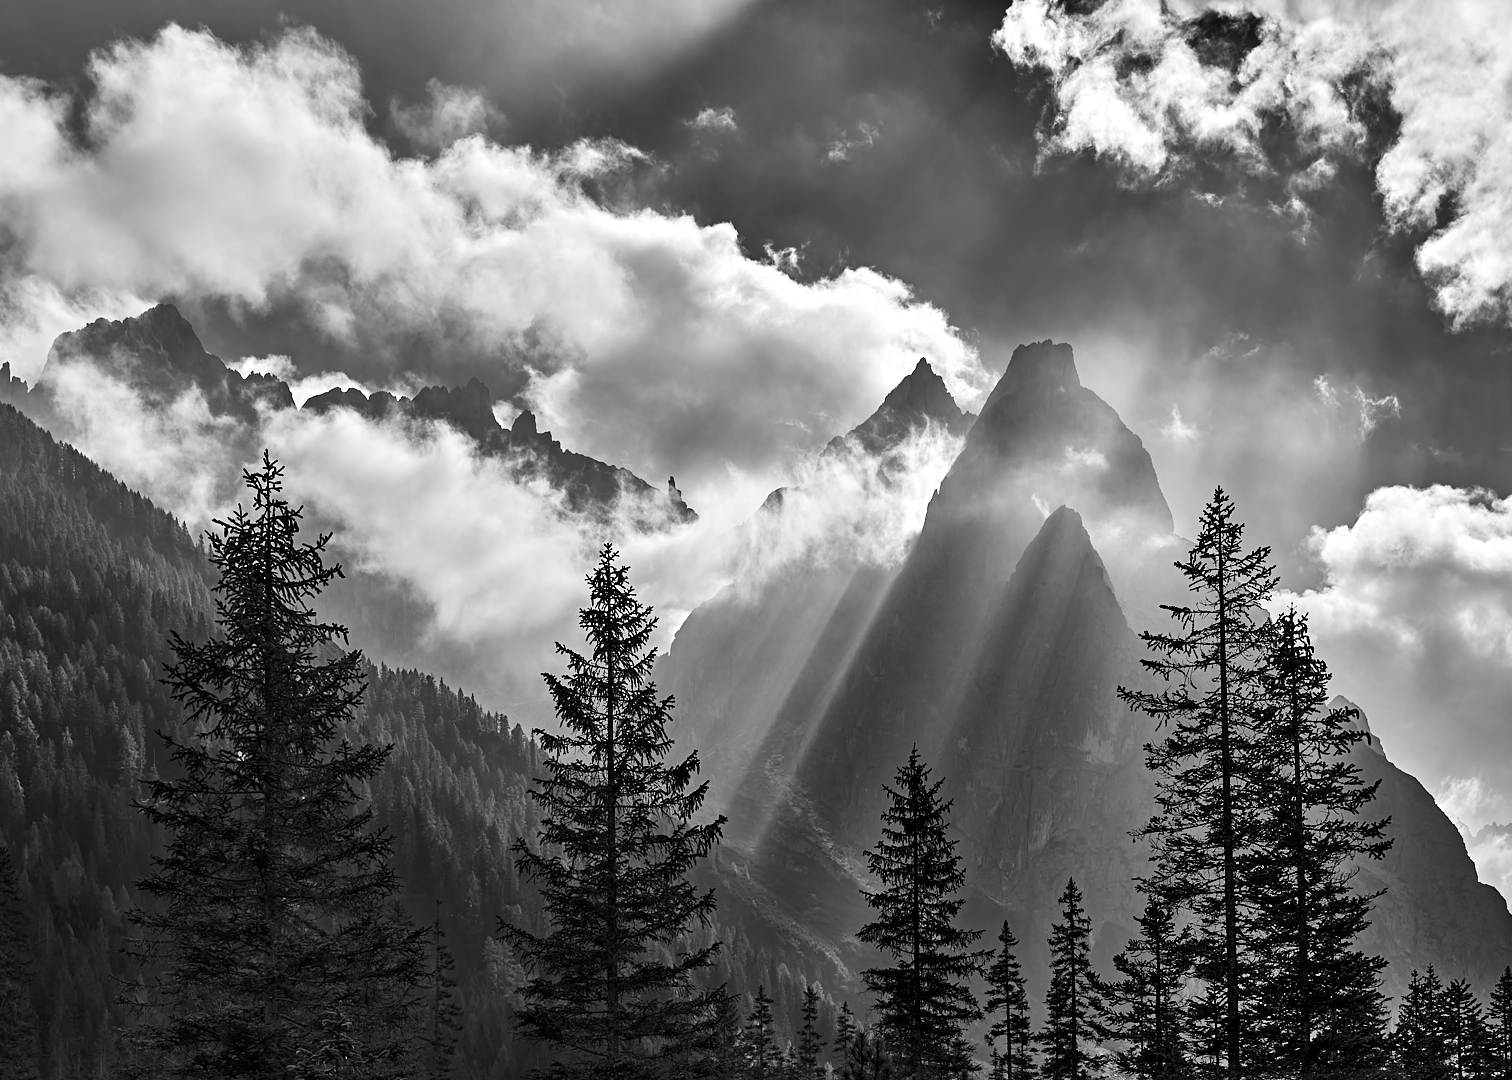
xmin=0 ymin=0 xmax=1512 ymax=562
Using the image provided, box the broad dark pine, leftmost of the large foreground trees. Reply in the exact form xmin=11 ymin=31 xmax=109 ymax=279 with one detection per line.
xmin=129 ymin=454 xmax=425 ymax=1080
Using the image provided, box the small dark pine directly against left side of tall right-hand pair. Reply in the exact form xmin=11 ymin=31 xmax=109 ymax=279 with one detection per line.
xmin=1098 ymin=898 xmax=1194 ymax=1080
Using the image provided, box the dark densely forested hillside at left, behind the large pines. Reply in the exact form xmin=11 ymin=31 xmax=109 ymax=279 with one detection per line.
xmin=0 ymin=405 xmax=562 ymax=1077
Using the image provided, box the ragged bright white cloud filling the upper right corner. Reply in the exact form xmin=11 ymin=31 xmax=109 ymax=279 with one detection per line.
xmin=992 ymin=0 xmax=1512 ymax=328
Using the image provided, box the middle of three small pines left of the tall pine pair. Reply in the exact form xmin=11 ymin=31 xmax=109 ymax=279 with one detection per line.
xmin=1039 ymin=879 xmax=1104 ymax=1080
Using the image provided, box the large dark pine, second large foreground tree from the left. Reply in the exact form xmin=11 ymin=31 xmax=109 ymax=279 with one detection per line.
xmin=500 ymin=545 xmax=724 ymax=1078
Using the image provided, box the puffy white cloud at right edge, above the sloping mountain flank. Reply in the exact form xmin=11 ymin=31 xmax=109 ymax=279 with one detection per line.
xmin=1276 ymin=486 xmax=1512 ymax=871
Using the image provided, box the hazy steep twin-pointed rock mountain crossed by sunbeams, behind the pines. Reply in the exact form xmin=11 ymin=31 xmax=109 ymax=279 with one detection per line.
xmin=659 ymin=342 xmax=1512 ymax=994
